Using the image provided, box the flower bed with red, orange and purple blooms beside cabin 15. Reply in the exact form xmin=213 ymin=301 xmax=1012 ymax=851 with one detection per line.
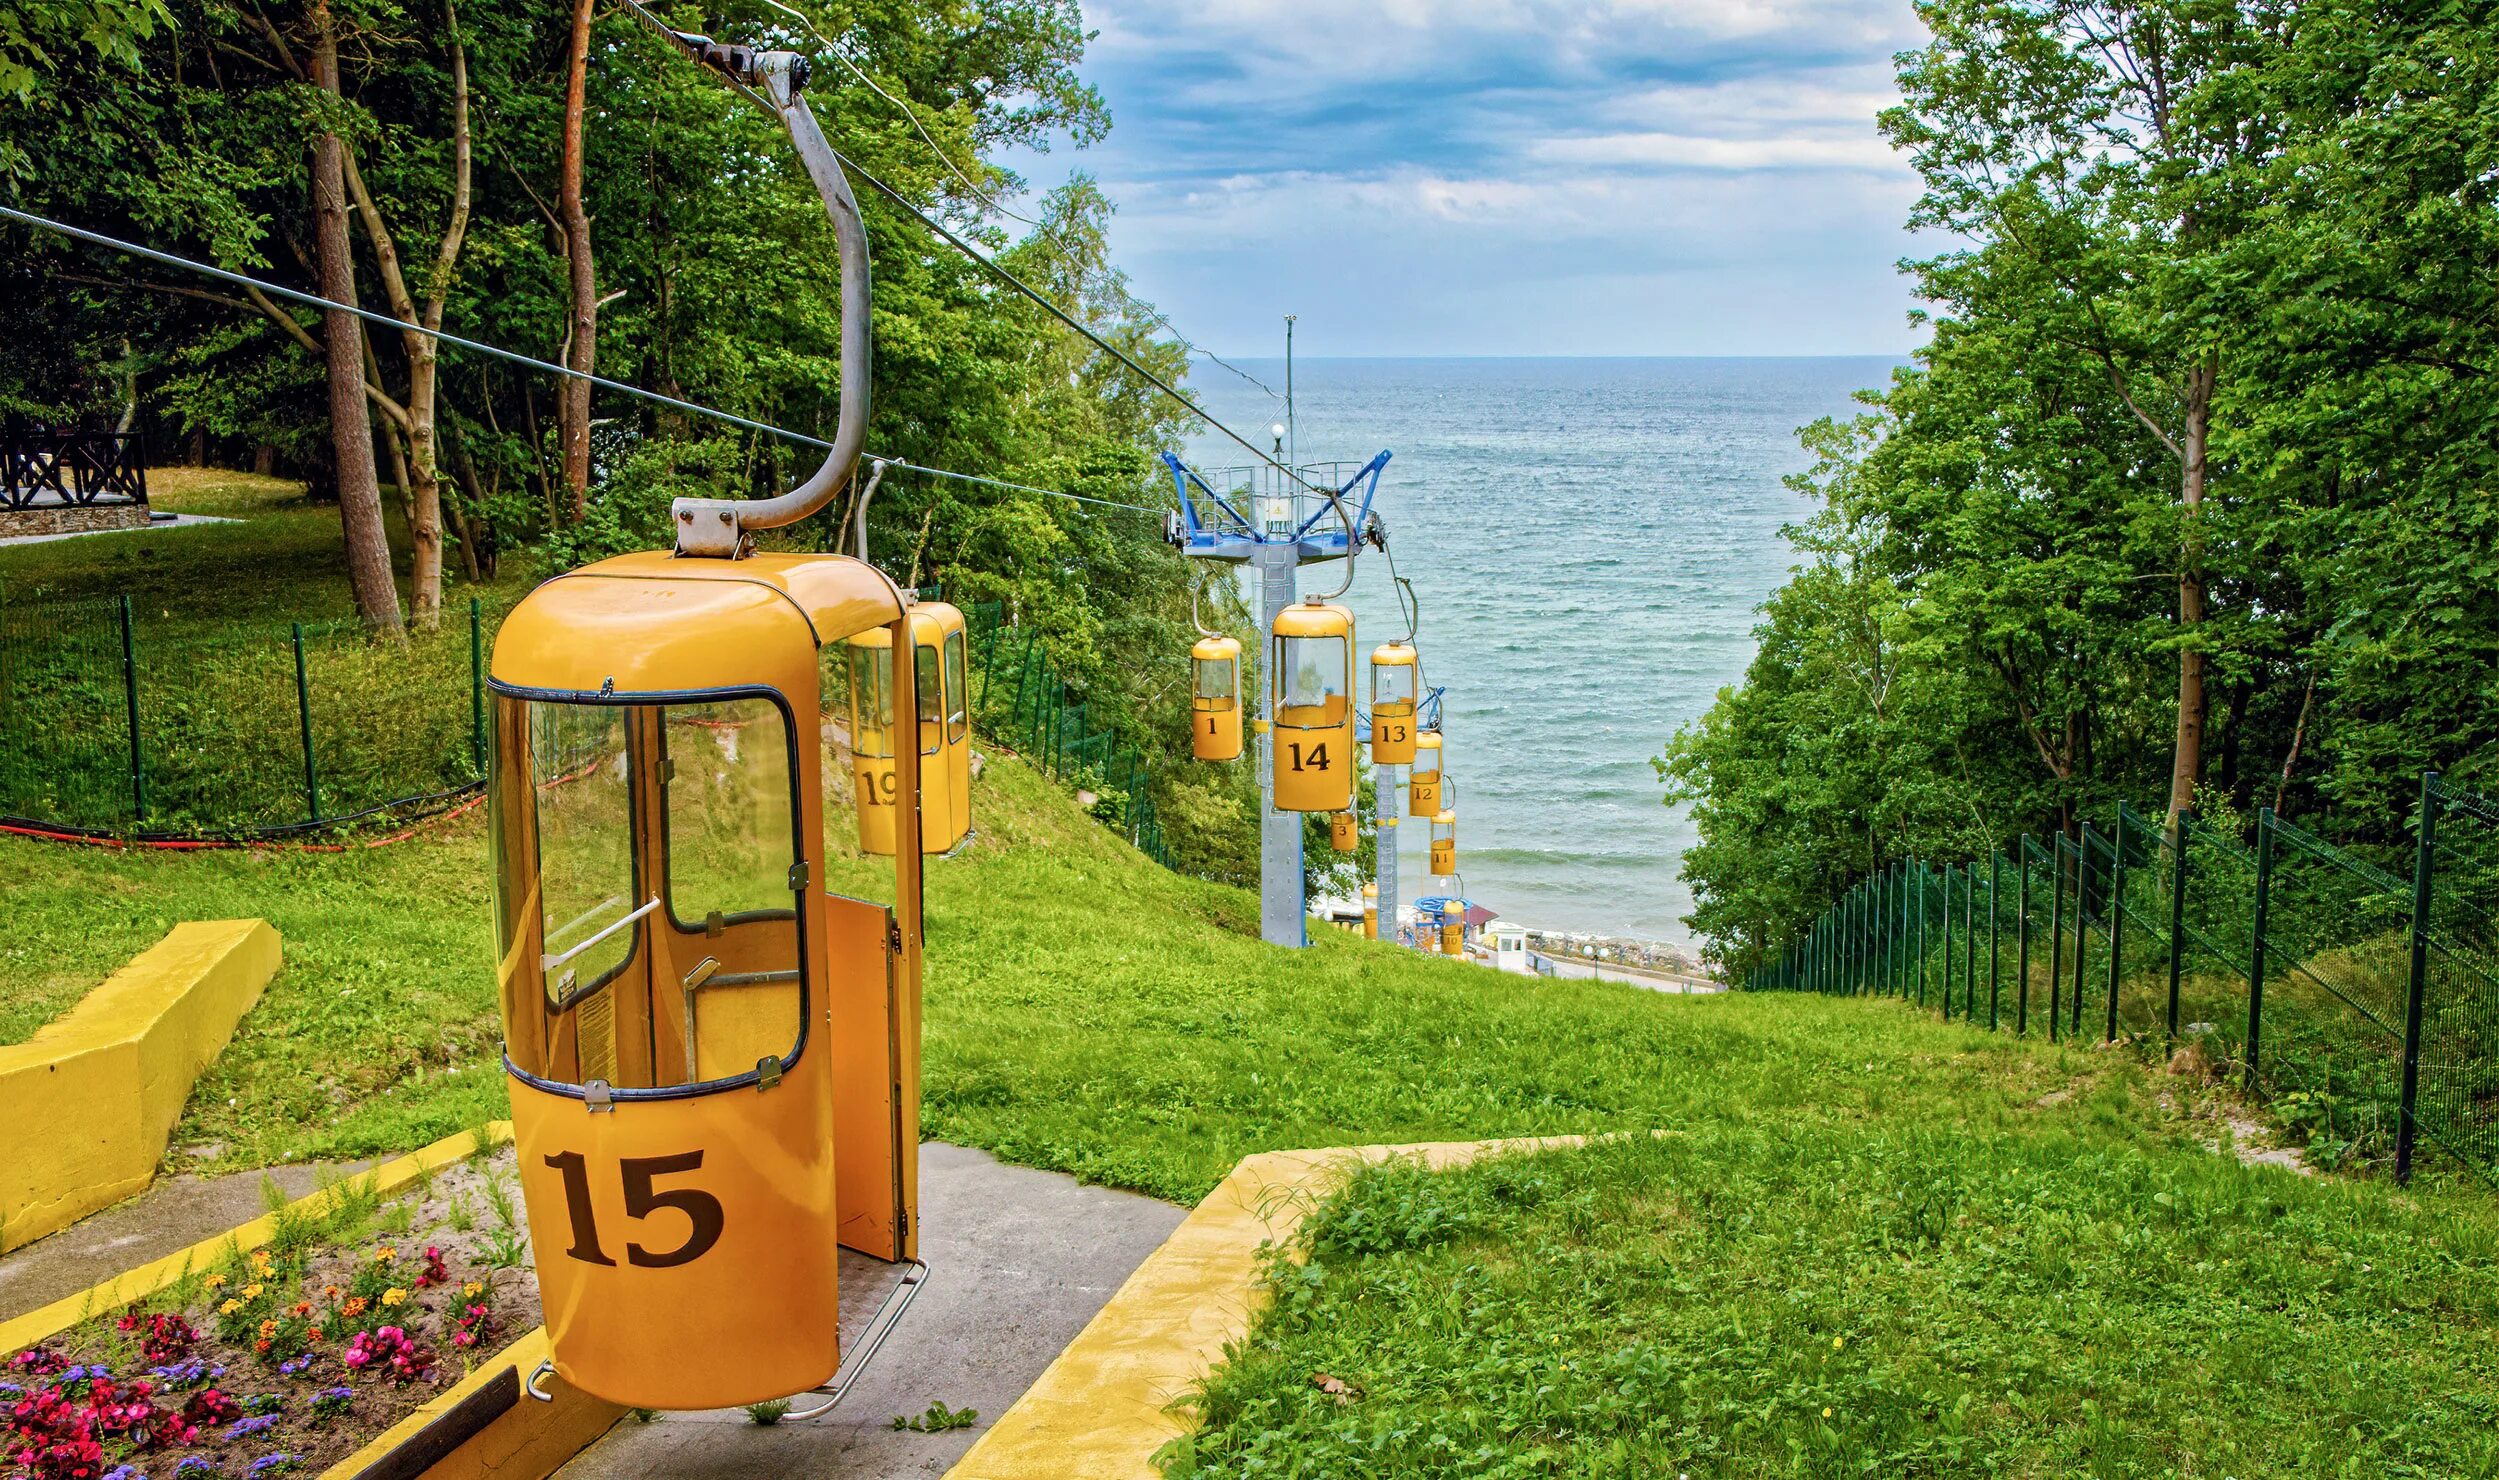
xmin=0 ymin=1148 xmax=537 ymax=1480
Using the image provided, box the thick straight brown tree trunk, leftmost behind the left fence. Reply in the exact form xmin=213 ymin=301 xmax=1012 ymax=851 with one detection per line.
xmin=310 ymin=0 xmax=400 ymax=633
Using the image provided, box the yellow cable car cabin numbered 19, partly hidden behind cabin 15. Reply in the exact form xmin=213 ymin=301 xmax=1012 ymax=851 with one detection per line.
xmin=847 ymin=603 xmax=972 ymax=855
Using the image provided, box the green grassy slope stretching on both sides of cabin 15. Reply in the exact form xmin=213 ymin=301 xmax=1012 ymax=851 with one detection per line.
xmin=14 ymin=477 xmax=2499 ymax=1475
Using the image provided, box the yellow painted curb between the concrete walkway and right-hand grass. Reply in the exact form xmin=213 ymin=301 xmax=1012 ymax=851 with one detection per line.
xmin=947 ymin=1135 xmax=1587 ymax=1480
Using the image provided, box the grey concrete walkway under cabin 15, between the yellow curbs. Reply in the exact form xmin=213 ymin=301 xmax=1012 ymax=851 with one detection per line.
xmin=557 ymin=1143 xmax=1187 ymax=1480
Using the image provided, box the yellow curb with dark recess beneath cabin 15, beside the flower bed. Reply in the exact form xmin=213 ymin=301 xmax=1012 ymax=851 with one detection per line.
xmin=322 ymin=1328 xmax=625 ymax=1480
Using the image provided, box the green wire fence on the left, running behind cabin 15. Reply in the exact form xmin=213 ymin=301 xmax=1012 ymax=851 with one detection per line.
xmin=0 ymin=598 xmax=1172 ymax=868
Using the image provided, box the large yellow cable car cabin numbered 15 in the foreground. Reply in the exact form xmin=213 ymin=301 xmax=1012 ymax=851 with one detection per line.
xmin=487 ymin=553 xmax=924 ymax=1408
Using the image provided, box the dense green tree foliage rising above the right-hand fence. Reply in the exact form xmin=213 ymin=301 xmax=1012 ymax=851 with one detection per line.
xmin=1659 ymin=0 xmax=2499 ymax=965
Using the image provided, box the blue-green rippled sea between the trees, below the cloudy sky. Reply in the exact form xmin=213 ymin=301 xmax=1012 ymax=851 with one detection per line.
xmin=1190 ymin=358 xmax=1897 ymax=945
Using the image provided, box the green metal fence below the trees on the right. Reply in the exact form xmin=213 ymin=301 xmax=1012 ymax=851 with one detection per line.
xmin=1744 ymin=773 xmax=2499 ymax=1178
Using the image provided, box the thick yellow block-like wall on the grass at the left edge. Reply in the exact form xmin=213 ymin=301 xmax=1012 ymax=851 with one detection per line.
xmin=0 ymin=920 xmax=277 ymax=1250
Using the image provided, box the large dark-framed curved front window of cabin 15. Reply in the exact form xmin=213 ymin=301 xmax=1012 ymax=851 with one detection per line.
xmin=490 ymin=693 xmax=807 ymax=1095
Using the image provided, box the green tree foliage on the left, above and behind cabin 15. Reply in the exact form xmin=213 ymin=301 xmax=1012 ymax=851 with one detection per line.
xmin=0 ymin=0 xmax=1269 ymax=873
